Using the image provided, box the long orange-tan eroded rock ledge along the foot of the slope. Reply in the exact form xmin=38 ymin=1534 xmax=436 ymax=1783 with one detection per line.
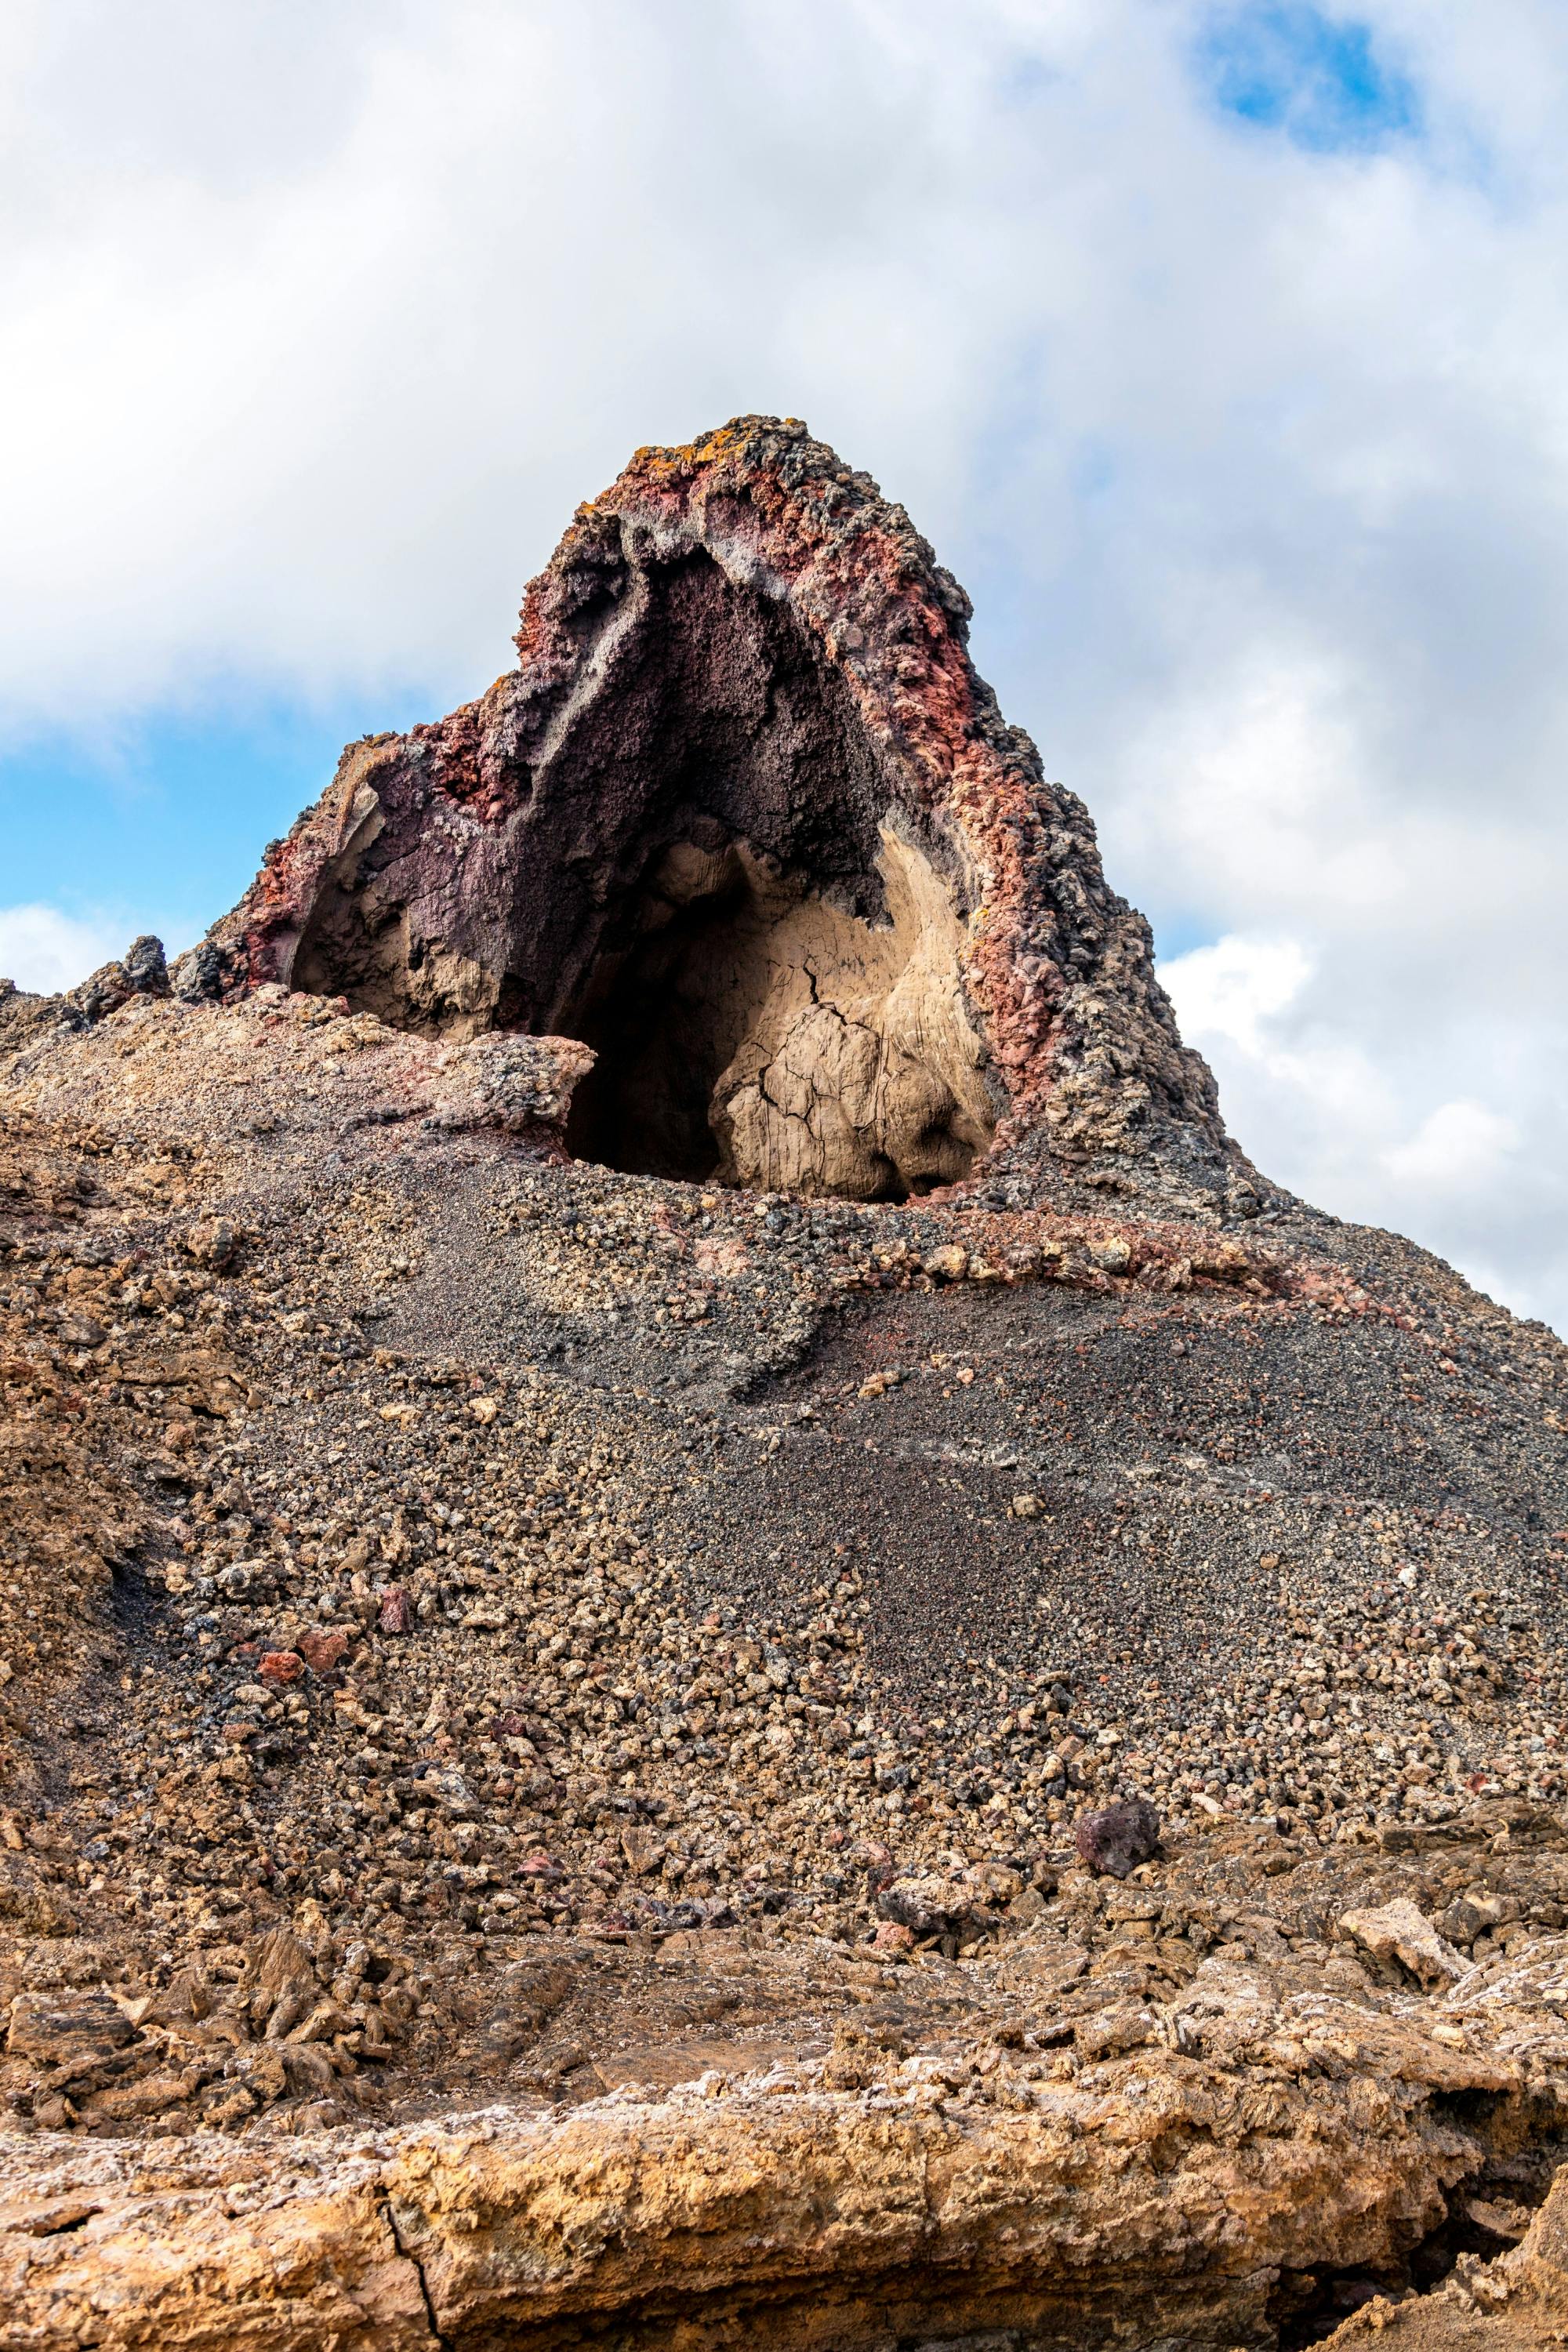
xmin=0 ymin=1973 xmax=1563 ymax=2352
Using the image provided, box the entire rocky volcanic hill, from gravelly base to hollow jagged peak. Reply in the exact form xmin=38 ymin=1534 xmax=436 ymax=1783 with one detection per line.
xmin=0 ymin=419 xmax=1568 ymax=2352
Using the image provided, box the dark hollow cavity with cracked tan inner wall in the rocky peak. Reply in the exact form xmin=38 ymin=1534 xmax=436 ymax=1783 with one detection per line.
xmin=294 ymin=555 xmax=996 ymax=1200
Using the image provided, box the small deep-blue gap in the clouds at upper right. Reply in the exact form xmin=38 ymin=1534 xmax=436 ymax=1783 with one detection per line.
xmin=1196 ymin=0 xmax=1420 ymax=155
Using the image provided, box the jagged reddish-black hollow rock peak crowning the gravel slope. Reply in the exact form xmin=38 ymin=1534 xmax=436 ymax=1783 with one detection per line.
xmin=201 ymin=416 xmax=1243 ymax=1200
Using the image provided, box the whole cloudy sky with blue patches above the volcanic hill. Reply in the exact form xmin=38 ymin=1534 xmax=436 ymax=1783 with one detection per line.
xmin=0 ymin=0 xmax=1568 ymax=1329
